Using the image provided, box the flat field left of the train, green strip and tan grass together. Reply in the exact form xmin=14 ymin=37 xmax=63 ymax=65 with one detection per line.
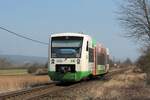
xmin=0 ymin=69 xmax=49 ymax=93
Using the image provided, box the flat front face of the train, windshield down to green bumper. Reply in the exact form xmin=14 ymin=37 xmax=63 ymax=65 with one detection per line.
xmin=48 ymin=34 xmax=83 ymax=82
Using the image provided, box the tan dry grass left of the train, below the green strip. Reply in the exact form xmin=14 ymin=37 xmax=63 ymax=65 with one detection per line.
xmin=0 ymin=75 xmax=49 ymax=93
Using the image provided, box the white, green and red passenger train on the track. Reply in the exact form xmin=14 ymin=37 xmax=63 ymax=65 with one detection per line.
xmin=48 ymin=33 xmax=109 ymax=82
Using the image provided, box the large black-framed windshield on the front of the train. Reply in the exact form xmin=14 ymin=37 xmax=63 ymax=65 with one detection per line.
xmin=51 ymin=36 xmax=83 ymax=58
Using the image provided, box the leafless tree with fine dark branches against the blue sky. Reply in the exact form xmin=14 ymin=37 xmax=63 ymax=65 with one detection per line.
xmin=119 ymin=0 xmax=150 ymax=43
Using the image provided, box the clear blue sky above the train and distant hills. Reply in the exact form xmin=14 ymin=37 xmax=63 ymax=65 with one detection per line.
xmin=0 ymin=0 xmax=139 ymax=60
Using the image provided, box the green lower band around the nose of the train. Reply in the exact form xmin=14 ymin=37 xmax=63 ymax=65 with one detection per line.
xmin=48 ymin=71 xmax=91 ymax=81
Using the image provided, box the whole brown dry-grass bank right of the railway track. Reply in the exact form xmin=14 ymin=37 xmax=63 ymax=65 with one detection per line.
xmin=45 ymin=68 xmax=150 ymax=100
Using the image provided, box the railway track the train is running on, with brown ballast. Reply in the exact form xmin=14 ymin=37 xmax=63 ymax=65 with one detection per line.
xmin=0 ymin=68 xmax=129 ymax=100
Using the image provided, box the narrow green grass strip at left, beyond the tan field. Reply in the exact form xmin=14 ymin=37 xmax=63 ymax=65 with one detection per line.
xmin=0 ymin=69 xmax=28 ymax=75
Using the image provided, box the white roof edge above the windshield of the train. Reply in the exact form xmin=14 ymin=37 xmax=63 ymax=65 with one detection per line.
xmin=50 ymin=32 xmax=90 ymax=37
